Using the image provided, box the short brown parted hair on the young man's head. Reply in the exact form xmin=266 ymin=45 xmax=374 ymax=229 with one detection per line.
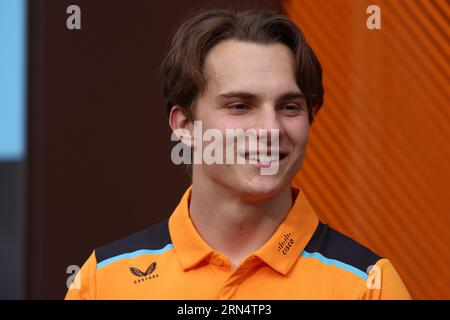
xmin=162 ymin=9 xmax=323 ymax=123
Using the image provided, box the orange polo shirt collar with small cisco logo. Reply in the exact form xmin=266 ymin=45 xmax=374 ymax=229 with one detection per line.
xmin=169 ymin=187 xmax=318 ymax=275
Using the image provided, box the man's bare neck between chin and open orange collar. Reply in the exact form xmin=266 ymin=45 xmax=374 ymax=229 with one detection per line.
xmin=189 ymin=172 xmax=292 ymax=266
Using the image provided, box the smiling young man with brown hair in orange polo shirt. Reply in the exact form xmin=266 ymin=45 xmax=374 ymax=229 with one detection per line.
xmin=66 ymin=10 xmax=410 ymax=299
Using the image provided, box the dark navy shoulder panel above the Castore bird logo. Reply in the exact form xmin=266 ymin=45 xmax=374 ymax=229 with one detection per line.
xmin=95 ymin=219 xmax=171 ymax=263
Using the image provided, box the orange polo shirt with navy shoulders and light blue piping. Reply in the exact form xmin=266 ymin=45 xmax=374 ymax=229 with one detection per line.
xmin=66 ymin=188 xmax=410 ymax=299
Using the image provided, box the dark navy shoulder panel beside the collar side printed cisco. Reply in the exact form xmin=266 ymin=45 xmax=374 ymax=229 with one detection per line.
xmin=305 ymin=222 xmax=381 ymax=272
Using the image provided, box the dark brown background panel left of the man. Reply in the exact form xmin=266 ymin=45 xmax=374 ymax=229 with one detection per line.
xmin=26 ymin=0 xmax=280 ymax=298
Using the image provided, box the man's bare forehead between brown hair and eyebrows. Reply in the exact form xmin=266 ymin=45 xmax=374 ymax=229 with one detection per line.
xmin=204 ymin=39 xmax=299 ymax=93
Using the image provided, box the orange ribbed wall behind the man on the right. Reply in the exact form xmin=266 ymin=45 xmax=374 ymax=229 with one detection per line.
xmin=282 ymin=0 xmax=450 ymax=299
